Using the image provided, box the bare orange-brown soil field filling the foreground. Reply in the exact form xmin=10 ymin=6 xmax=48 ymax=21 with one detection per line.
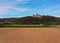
xmin=0 ymin=28 xmax=60 ymax=43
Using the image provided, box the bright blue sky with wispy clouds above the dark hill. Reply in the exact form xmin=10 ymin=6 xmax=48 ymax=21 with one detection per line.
xmin=0 ymin=0 xmax=60 ymax=18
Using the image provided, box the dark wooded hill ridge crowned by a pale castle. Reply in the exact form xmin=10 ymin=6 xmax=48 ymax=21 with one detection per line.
xmin=0 ymin=14 xmax=60 ymax=25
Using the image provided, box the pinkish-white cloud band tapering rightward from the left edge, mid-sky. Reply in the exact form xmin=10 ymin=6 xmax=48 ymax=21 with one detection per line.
xmin=0 ymin=6 xmax=30 ymax=15
